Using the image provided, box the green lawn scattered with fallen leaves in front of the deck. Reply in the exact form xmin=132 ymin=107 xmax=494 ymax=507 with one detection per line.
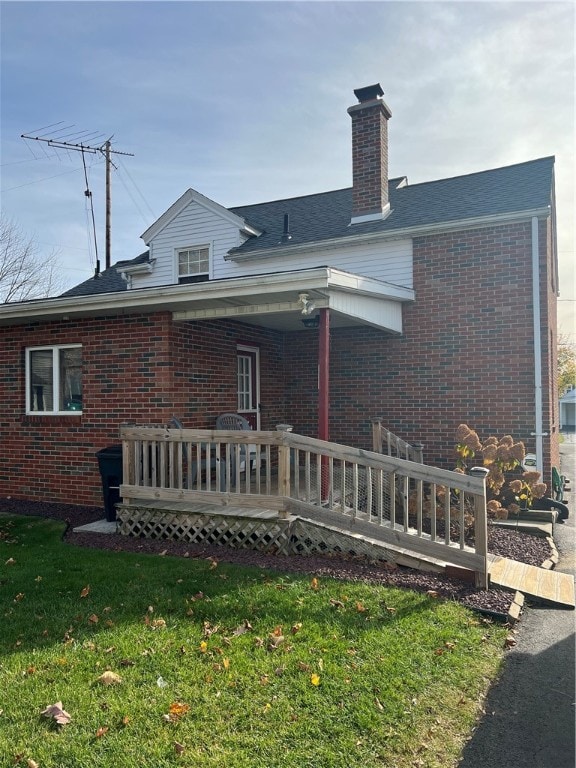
xmin=0 ymin=517 xmax=506 ymax=768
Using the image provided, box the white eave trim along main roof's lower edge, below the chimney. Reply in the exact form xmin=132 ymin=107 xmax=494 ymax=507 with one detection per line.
xmin=224 ymin=205 xmax=551 ymax=261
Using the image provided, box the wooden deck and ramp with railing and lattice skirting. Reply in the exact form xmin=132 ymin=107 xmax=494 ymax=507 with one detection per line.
xmin=118 ymin=427 xmax=488 ymax=588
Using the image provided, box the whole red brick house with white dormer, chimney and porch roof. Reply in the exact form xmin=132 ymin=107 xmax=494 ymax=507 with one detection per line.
xmin=0 ymin=85 xmax=559 ymax=504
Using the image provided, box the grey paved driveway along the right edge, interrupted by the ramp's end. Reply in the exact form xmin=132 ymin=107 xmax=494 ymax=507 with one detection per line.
xmin=459 ymin=435 xmax=576 ymax=768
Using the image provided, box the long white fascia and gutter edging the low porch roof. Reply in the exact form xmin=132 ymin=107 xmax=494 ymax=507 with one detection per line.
xmin=0 ymin=267 xmax=415 ymax=325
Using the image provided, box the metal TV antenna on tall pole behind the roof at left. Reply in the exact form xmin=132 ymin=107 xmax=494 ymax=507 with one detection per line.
xmin=20 ymin=127 xmax=134 ymax=276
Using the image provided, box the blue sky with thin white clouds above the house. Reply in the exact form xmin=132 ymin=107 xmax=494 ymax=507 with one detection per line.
xmin=0 ymin=0 xmax=576 ymax=340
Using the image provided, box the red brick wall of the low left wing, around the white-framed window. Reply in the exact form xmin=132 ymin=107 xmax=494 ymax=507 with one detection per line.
xmin=0 ymin=313 xmax=284 ymax=505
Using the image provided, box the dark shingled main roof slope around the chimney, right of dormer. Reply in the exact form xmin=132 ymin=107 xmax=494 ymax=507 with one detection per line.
xmin=230 ymin=157 xmax=554 ymax=256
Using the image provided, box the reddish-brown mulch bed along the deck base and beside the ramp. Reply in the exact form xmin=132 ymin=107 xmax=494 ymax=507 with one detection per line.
xmin=0 ymin=498 xmax=551 ymax=616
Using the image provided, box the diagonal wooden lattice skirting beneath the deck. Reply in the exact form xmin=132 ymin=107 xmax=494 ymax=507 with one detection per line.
xmin=117 ymin=504 xmax=408 ymax=562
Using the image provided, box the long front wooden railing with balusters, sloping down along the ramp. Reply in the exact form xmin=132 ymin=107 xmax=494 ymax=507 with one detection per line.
xmin=120 ymin=427 xmax=488 ymax=588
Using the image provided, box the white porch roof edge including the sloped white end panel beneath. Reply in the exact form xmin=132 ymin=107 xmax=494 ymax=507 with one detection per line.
xmin=0 ymin=267 xmax=414 ymax=333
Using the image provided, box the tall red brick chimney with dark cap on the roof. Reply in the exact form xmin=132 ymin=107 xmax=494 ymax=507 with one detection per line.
xmin=348 ymin=83 xmax=392 ymax=224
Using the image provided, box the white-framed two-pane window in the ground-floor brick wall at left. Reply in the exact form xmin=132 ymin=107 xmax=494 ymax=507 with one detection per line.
xmin=26 ymin=345 xmax=82 ymax=414
